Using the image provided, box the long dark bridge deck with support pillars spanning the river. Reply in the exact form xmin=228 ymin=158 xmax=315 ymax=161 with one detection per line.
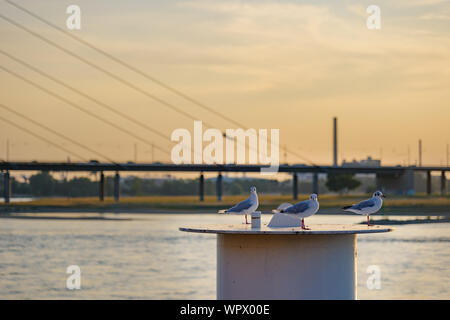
xmin=0 ymin=161 xmax=450 ymax=203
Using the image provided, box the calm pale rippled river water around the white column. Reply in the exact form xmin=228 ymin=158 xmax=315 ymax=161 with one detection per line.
xmin=0 ymin=214 xmax=450 ymax=299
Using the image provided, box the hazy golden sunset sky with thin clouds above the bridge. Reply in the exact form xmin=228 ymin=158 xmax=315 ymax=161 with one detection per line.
xmin=0 ymin=0 xmax=450 ymax=165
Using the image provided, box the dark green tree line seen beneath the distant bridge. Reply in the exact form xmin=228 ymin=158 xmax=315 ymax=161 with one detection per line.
xmin=0 ymin=172 xmax=390 ymax=197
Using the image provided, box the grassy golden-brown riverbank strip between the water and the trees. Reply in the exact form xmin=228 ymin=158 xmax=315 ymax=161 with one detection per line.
xmin=0 ymin=195 xmax=450 ymax=216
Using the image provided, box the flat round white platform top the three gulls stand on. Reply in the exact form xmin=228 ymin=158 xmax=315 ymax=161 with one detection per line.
xmin=180 ymin=224 xmax=394 ymax=234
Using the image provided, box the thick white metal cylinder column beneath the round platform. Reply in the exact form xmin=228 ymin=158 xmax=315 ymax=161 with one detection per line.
xmin=217 ymin=234 xmax=357 ymax=300
